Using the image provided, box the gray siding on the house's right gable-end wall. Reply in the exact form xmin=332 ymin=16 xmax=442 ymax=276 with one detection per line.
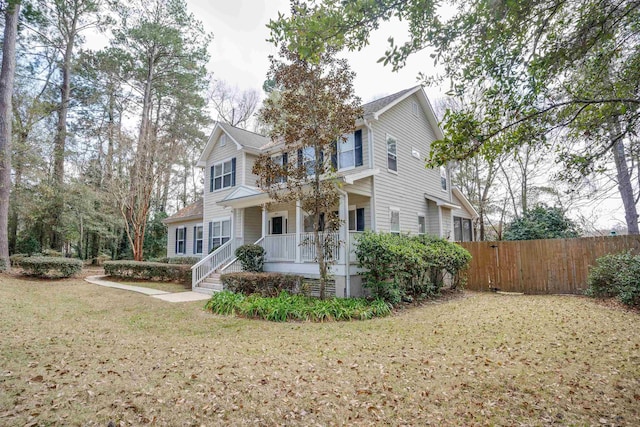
xmin=372 ymin=94 xmax=451 ymax=235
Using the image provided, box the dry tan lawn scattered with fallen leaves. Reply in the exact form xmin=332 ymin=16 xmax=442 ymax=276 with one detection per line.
xmin=0 ymin=275 xmax=640 ymax=426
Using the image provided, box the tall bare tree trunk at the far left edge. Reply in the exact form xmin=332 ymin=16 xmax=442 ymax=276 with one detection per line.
xmin=0 ymin=1 xmax=20 ymax=270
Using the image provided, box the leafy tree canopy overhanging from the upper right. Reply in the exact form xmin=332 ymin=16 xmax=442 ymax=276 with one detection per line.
xmin=270 ymin=0 xmax=640 ymax=233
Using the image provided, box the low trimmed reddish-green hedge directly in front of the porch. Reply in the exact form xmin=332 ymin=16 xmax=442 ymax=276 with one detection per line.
xmin=220 ymin=271 xmax=302 ymax=297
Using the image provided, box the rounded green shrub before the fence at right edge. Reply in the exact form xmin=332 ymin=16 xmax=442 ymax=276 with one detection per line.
xmin=585 ymin=252 xmax=640 ymax=305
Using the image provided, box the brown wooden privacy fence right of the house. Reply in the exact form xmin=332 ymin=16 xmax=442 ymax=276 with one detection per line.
xmin=460 ymin=235 xmax=640 ymax=294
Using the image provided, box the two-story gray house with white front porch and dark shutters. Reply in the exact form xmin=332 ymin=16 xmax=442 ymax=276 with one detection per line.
xmin=164 ymin=86 xmax=477 ymax=296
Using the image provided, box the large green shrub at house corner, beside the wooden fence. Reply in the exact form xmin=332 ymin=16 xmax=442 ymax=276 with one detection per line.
xmin=356 ymin=231 xmax=471 ymax=304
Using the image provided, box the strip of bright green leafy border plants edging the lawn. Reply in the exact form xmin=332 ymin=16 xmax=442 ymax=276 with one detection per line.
xmin=206 ymin=290 xmax=391 ymax=322
